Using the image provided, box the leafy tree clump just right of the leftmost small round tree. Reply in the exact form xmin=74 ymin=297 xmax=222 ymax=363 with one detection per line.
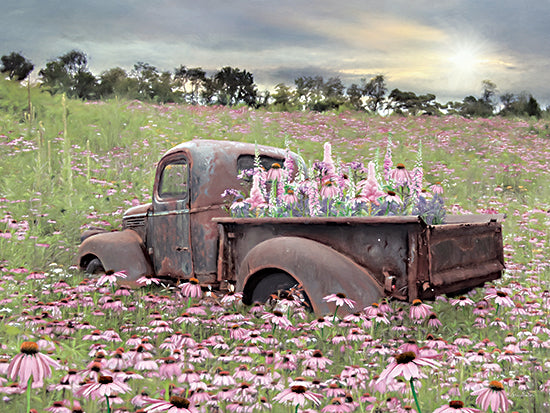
xmin=38 ymin=50 xmax=97 ymax=99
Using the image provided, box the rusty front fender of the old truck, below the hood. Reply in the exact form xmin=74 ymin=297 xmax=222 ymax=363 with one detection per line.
xmin=76 ymin=229 xmax=153 ymax=286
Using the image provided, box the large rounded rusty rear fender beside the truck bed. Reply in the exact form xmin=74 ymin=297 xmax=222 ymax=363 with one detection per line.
xmin=236 ymin=237 xmax=384 ymax=314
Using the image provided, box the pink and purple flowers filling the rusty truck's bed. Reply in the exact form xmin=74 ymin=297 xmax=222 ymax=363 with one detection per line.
xmin=222 ymin=138 xmax=445 ymax=225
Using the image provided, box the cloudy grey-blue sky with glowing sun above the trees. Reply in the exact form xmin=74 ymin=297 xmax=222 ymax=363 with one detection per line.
xmin=0 ymin=0 xmax=550 ymax=104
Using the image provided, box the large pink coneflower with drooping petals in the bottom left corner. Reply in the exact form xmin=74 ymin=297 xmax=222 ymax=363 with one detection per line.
xmin=7 ymin=341 xmax=61 ymax=387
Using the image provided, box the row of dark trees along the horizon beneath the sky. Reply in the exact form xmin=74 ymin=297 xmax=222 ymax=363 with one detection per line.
xmin=0 ymin=50 xmax=550 ymax=117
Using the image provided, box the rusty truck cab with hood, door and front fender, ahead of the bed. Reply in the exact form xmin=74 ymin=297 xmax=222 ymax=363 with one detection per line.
xmin=77 ymin=140 xmax=296 ymax=287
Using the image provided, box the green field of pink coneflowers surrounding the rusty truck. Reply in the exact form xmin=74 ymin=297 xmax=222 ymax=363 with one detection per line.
xmin=0 ymin=81 xmax=550 ymax=413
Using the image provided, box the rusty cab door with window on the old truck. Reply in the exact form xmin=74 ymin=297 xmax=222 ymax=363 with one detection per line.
xmin=151 ymin=154 xmax=193 ymax=278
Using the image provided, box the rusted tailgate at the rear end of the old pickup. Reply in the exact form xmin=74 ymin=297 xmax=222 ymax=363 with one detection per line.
xmin=427 ymin=215 xmax=504 ymax=294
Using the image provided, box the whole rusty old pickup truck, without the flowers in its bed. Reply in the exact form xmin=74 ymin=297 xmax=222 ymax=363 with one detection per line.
xmin=77 ymin=140 xmax=504 ymax=314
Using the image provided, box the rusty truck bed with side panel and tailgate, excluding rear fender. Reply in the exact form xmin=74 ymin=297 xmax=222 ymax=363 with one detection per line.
xmin=214 ymin=215 xmax=504 ymax=305
